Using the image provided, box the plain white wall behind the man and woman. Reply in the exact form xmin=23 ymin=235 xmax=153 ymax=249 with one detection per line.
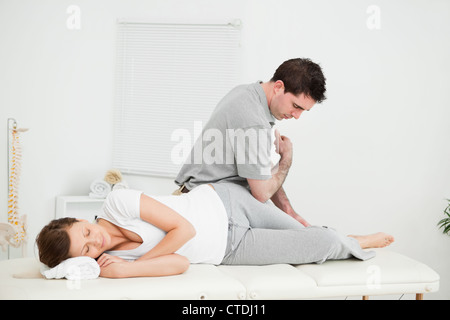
xmin=0 ymin=0 xmax=450 ymax=299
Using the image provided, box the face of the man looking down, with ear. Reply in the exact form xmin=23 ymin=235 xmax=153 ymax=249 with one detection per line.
xmin=269 ymin=81 xmax=316 ymax=120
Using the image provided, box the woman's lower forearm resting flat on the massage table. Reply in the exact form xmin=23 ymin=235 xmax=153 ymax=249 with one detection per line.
xmin=100 ymin=254 xmax=189 ymax=278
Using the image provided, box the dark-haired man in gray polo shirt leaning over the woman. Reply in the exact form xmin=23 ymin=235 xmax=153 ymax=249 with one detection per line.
xmin=175 ymin=59 xmax=326 ymax=226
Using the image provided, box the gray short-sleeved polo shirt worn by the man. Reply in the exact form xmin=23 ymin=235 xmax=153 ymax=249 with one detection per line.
xmin=175 ymin=82 xmax=275 ymax=190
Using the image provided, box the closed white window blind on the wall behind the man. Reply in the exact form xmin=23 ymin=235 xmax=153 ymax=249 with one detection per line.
xmin=113 ymin=21 xmax=240 ymax=178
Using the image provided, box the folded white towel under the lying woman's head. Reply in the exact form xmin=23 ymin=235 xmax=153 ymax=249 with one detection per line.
xmin=41 ymin=257 xmax=100 ymax=280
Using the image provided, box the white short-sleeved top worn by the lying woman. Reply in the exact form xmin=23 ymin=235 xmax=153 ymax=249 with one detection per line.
xmin=98 ymin=185 xmax=228 ymax=264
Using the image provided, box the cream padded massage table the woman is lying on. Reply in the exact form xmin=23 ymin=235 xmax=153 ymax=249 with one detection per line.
xmin=0 ymin=249 xmax=439 ymax=300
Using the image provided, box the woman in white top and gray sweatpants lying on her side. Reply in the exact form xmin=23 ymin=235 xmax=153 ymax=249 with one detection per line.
xmin=36 ymin=183 xmax=394 ymax=278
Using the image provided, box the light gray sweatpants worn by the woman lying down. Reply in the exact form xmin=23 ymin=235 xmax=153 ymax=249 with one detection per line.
xmin=213 ymin=183 xmax=375 ymax=265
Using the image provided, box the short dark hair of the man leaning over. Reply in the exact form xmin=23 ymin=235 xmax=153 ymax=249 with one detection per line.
xmin=270 ymin=58 xmax=326 ymax=103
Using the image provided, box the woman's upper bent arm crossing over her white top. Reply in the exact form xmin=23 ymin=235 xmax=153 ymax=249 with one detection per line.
xmin=137 ymin=194 xmax=195 ymax=261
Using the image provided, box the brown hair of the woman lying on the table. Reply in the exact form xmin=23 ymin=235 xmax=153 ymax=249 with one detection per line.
xmin=36 ymin=218 xmax=78 ymax=268
